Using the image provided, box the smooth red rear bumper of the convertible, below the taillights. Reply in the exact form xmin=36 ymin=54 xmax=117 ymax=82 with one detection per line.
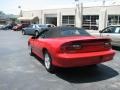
xmin=52 ymin=50 xmax=115 ymax=68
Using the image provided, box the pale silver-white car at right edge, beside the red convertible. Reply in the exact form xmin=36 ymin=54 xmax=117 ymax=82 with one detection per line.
xmin=91 ymin=25 xmax=120 ymax=47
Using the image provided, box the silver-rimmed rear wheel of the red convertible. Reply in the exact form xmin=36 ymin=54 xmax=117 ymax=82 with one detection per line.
xmin=44 ymin=51 xmax=55 ymax=73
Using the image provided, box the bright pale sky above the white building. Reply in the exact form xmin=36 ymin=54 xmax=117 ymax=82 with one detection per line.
xmin=0 ymin=0 xmax=119 ymax=15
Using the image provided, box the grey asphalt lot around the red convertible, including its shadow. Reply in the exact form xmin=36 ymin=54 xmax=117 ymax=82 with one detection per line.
xmin=0 ymin=30 xmax=120 ymax=90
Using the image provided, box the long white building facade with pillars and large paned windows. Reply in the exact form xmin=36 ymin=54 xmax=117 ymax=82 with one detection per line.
xmin=22 ymin=5 xmax=120 ymax=30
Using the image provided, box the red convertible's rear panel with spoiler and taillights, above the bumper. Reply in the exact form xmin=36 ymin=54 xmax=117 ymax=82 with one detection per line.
xmin=55 ymin=37 xmax=111 ymax=53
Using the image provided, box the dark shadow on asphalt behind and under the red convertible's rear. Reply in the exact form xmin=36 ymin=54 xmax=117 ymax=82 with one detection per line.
xmin=55 ymin=64 xmax=119 ymax=83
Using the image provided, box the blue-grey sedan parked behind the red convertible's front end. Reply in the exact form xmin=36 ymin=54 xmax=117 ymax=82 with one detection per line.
xmin=22 ymin=24 xmax=49 ymax=36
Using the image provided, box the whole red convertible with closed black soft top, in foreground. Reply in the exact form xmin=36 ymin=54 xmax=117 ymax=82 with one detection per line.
xmin=28 ymin=27 xmax=115 ymax=72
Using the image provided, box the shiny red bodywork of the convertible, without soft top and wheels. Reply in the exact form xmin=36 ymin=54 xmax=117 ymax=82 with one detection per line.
xmin=28 ymin=36 xmax=115 ymax=67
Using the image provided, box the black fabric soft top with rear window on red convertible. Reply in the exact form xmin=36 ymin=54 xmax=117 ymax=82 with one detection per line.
xmin=40 ymin=26 xmax=90 ymax=38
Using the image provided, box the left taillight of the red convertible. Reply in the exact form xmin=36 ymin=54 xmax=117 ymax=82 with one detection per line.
xmin=61 ymin=43 xmax=82 ymax=52
